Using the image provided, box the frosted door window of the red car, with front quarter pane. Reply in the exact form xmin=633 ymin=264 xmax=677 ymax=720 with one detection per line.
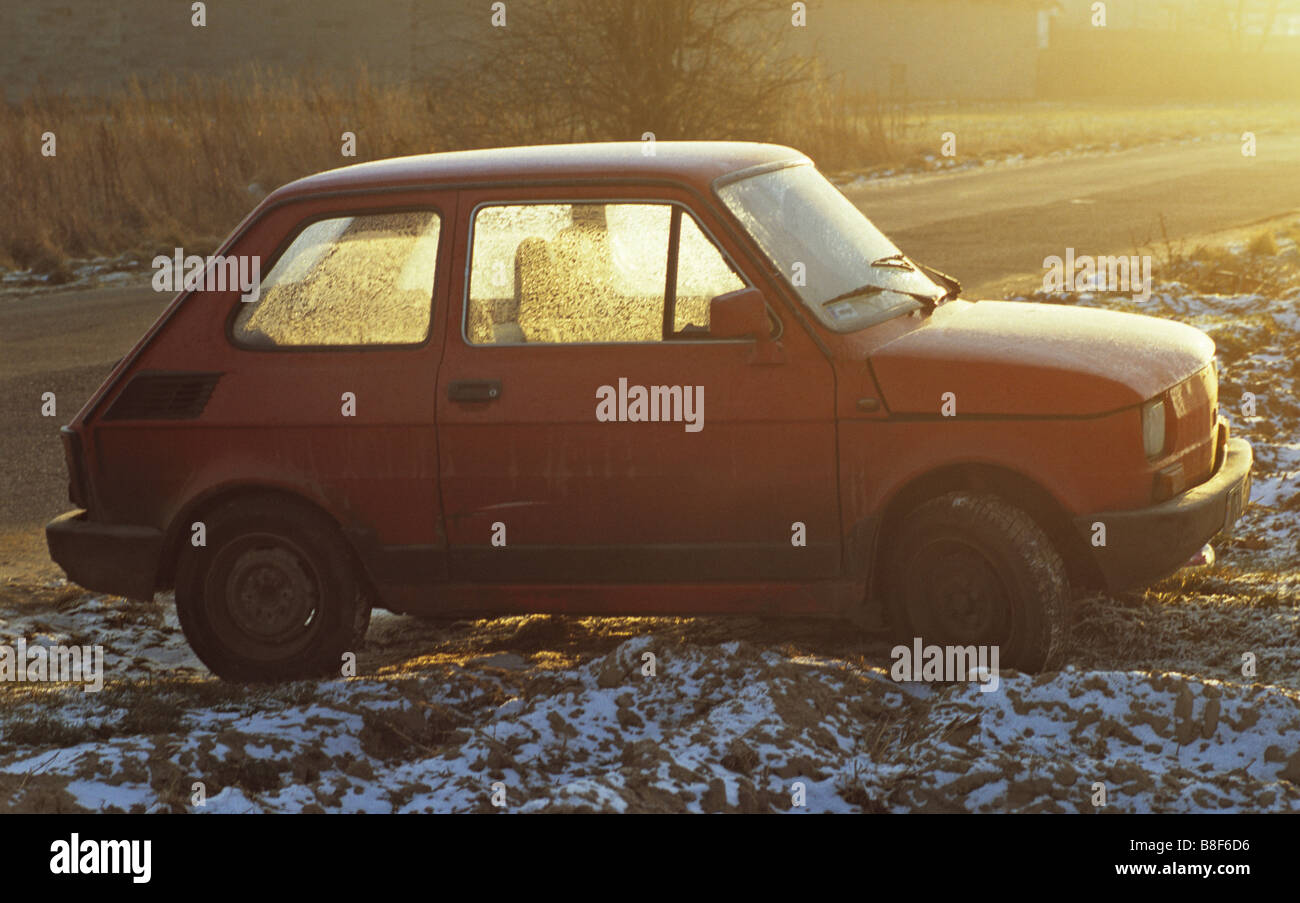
xmin=465 ymin=203 xmax=745 ymax=344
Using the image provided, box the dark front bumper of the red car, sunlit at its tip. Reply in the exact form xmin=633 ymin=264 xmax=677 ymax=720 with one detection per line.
xmin=1074 ymin=439 xmax=1255 ymax=592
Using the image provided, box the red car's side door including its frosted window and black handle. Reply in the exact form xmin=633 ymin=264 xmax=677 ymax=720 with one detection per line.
xmin=438 ymin=190 xmax=840 ymax=582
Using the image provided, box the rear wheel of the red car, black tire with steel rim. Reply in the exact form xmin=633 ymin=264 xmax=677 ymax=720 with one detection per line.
xmin=176 ymin=499 xmax=371 ymax=682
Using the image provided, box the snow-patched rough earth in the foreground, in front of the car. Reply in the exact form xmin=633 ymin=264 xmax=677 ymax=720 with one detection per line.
xmin=0 ymin=621 xmax=1300 ymax=812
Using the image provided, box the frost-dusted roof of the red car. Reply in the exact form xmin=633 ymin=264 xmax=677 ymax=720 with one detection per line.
xmin=267 ymin=142 xmax=807 ymax=201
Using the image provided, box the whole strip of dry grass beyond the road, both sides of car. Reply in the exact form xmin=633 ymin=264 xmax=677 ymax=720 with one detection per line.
xmin=0 ymin=68 xmax=1300 ymax=271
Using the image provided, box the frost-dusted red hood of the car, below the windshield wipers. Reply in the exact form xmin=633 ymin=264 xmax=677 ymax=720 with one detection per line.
xmin=870 ymin=301 xmax=1214 ymax=416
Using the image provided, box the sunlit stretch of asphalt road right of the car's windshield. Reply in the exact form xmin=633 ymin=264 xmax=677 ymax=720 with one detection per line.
xmin=845 ymin=135 xmax=1300 ymax=298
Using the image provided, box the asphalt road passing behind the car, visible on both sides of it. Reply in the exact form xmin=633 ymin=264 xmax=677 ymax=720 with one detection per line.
xmin=0 ymin=135 xmax=1300 ymax=578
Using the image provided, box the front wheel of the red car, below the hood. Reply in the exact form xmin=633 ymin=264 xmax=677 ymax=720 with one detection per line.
xmin=883 ymin=491 xmax=1070 ymax=672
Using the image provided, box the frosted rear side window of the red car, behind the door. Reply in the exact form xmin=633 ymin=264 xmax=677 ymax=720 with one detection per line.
xmin=233 ymin=210 xmax=441 ymax=348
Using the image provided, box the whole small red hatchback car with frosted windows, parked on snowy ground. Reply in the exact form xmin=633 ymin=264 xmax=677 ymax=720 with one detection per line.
xmin=47 ymin=142 xmax=1252 ymax=680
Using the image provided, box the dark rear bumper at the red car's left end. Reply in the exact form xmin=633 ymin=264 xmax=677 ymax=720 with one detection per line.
xmin=46 ymin=509 xmax=163 ymax=600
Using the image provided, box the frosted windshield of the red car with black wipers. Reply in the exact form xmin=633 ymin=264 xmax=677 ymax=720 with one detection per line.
xmin=718 ymin=164 xmax=945 ymax=333
